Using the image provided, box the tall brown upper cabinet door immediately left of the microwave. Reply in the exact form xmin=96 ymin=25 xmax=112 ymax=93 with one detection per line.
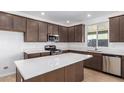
xmin=39 ymin=22 xmax=47 ymax=42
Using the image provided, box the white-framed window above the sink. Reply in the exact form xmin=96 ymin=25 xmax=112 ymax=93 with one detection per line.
xmin=87 ymin=22 xmax=108 ymax=47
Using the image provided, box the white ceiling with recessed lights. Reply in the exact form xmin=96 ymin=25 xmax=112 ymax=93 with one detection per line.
xmin=21 ymin=11 xmax=115 ymax=25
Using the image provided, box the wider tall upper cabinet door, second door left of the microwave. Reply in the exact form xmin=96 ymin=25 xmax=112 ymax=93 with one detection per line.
xmin=25 ymin=19 xmax=38 ymax=42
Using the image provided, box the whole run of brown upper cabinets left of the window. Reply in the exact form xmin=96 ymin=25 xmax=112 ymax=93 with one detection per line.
xmin=0 ymin=12 xmax=85 ymax=42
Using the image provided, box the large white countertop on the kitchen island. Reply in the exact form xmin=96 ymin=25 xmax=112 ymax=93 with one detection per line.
xmin=15 ymin=53 xmax=92 ymax=80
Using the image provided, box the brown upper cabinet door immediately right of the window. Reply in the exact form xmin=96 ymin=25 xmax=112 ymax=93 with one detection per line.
xmin=109 ymin=17 xmax=120 ymax=42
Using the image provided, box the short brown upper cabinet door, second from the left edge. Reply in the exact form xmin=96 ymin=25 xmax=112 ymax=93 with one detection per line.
xmin=13 ymin=16 xmax=26 ymax=32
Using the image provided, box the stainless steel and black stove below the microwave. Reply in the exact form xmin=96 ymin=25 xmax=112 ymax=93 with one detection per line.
xmin=45 ymin=45 xmax=62 ymax=55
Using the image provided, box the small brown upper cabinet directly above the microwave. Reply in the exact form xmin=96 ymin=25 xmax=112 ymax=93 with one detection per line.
xmin=48 ymin=23 xmax=59 ymax=35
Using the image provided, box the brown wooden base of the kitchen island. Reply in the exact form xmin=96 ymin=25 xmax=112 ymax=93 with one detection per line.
xmin=16 ymin=62 xmax=84 ymax=82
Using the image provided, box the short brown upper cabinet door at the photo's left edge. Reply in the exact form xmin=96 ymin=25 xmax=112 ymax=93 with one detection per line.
xmin=0 ymin=12 xmax=13 ymax=30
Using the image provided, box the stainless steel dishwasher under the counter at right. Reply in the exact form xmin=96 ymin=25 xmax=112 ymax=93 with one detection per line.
xmin=103 ymin=55 xmax=121 ymax=76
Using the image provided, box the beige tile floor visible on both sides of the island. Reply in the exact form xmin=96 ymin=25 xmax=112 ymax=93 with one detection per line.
xmin=0 ymin=68 xmax=124 ymax=82
